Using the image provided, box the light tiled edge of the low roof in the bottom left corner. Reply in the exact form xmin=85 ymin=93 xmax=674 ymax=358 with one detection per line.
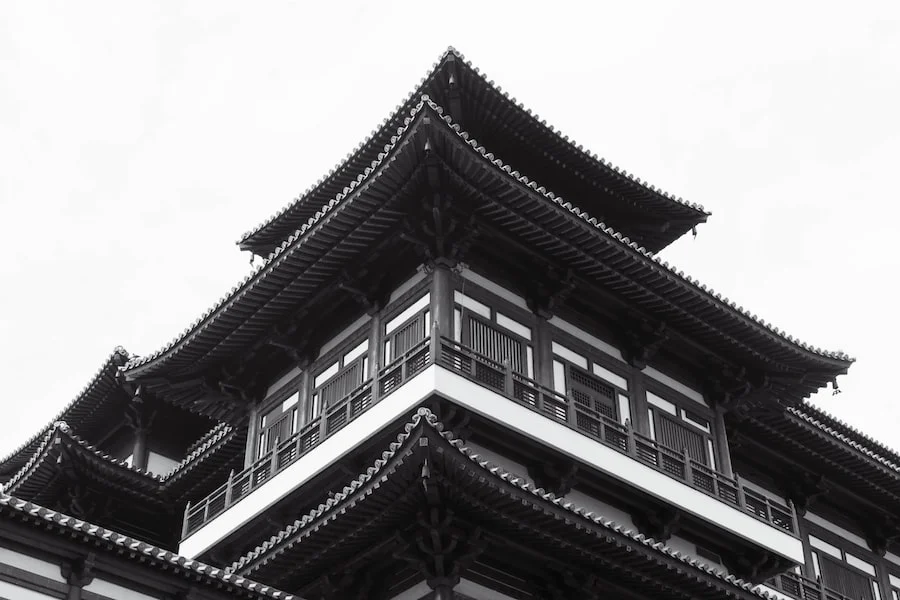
xmin=0 ymin=492 xmax=300 ymax=600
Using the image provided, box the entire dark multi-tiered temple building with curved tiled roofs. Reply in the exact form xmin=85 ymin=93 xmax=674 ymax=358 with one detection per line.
xmin=0 ymin=50 xmax=900 ymax=600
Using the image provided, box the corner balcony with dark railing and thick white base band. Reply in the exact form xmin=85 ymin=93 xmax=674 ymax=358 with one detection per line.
xmin=182 ymin=336 xmax=802 ymax=562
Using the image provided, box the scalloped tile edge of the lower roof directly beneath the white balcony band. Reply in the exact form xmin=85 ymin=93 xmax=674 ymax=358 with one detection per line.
xmin=226 ymin=407 xmax=775 ymax=600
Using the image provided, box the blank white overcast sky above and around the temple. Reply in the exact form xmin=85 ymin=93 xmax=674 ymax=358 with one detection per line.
xmin=0 ymin=0 xmax=900 ymax=455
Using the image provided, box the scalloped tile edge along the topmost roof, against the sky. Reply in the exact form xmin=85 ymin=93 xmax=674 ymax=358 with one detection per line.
xmin=236 ymin=46 xmax=710 ymax=246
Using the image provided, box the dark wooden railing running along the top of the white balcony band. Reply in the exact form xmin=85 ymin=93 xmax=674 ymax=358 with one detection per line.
xmin=182 ymin=336 xmax=800 ymax=540
